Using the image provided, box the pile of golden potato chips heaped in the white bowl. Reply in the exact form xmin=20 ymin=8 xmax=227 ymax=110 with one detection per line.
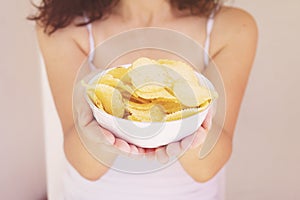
xmin=87 ymin=57 xmax=217 ymax=122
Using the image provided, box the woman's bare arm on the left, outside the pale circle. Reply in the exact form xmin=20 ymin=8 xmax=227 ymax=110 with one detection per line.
xmin=36 ymin=26 xmax=113 ymax=180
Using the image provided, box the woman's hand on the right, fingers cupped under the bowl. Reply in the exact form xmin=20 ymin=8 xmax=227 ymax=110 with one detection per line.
xmin=152 ymin=109 xmax=212 ymax=163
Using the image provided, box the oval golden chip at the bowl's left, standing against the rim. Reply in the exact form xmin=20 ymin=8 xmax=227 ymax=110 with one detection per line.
xmin=95 ymin=84 xmax=125 ymax=118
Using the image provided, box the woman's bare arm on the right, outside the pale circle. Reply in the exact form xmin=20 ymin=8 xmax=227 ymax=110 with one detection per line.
xmin=180 ymin=8 xmax=258 ymax=182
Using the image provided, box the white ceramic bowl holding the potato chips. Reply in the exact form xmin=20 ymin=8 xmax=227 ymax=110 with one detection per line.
xmin=85 ymin=66 xmax=215 ymax=148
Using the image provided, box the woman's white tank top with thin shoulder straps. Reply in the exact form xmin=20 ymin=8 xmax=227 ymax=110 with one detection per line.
xmin=63 ymin=9 xmax=225 ymax=200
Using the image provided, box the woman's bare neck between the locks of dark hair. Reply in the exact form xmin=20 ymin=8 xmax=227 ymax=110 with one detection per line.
xmin=113 ymin=0 xmax=173 ymax=26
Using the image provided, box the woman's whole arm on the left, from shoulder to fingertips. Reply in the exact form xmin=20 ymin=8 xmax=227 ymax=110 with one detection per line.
xmin=37 ymin=25 xmax=151 ymax=180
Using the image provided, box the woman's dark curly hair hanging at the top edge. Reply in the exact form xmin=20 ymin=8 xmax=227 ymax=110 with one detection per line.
xmin=28 ymin=0 xmax=222 ymax=34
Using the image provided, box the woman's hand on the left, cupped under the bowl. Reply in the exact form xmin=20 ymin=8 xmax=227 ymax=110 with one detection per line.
xmin=73 ymin=75 xmax=145 ymax=162
